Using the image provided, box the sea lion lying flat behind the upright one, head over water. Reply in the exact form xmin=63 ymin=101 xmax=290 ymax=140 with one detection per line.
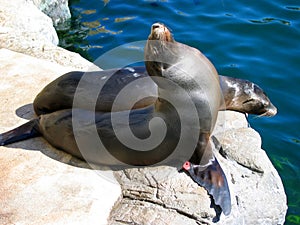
xmin=33 ymin=67 xmax=277 ymax=116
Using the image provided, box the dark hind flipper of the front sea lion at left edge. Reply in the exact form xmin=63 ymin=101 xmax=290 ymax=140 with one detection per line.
xmin=0 ymin=119 xmax=40 ymax=146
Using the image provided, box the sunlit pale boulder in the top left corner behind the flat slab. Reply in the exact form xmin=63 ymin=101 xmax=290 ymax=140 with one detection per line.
xmin=0 ymin=0 xmax=93 ymax=70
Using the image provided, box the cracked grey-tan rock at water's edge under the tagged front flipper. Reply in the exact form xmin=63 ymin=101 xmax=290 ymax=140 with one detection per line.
xmin=110 ymin=112 xmax=287 ymax=225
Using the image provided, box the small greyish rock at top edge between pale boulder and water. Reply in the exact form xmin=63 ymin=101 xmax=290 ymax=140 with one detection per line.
xmin=33 ymin=0 xmax=71 ymax=26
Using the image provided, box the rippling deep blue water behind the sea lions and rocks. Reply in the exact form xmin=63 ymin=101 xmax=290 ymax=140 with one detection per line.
xmin=59 ymin=0 xmax=300 ymax=225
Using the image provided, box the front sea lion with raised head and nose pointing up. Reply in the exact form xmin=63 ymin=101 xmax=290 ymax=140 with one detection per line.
xmin=0 ymin=23 xmax=231 ymax=215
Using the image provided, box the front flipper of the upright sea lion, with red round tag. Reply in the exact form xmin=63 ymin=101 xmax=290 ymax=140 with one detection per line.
xmin=183 ymin=158 xmax=231 ymax=216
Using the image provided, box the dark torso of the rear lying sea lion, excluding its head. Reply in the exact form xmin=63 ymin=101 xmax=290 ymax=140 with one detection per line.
xmin=33 ymin=67 xmax=157 ymax=115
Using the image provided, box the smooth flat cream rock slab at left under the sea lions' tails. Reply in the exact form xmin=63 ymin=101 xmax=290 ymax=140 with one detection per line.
xmin=0 ymin=49 xmax=121 ymax=224
